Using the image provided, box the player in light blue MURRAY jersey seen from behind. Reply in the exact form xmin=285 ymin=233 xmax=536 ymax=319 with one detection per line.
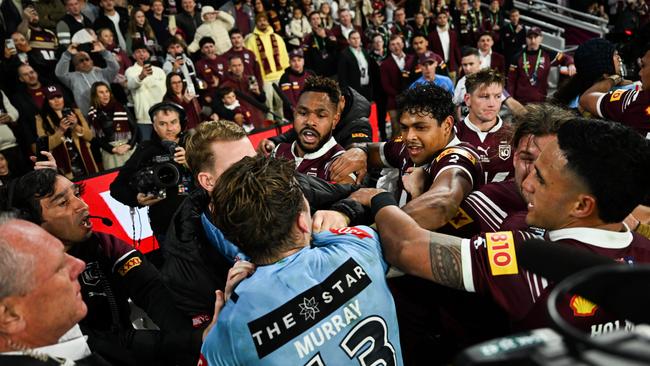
xmin=201 ymin=156 xmax=403 ymax=365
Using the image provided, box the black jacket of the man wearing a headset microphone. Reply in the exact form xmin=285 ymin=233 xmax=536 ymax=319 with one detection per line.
xmin=68 ymin=233 xmax=201 ymax=365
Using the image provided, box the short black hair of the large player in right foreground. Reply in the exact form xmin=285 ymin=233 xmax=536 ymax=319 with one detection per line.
xmin=557 ymin=118 xmax=650 ymax=223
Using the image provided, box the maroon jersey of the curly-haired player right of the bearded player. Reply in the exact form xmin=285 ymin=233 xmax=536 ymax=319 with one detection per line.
xmin=379 ymin=137 xmax=484 ymax=206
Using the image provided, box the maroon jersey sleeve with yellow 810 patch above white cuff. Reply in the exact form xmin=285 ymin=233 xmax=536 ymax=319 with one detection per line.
xmin=461 ymin=231 xmax=548 ymax=319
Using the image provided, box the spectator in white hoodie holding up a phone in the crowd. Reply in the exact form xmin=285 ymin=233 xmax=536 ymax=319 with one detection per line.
xmin=124 ymin=43 xmax=166 ymax=141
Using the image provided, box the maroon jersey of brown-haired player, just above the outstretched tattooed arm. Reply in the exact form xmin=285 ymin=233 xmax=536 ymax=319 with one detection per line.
xmin=437 ymin=180 xmax=528 ymax=238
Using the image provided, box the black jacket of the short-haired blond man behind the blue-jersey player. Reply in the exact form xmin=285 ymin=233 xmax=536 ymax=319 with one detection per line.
xmin=161 ymin=174 xmax=364 ymax=327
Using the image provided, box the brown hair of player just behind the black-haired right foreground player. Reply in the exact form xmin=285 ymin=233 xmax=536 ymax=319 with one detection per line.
xmin=512 ymin=103 xmax=576 ymax=147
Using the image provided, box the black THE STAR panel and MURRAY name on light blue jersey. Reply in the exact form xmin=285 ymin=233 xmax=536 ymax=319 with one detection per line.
xmin=248 ymin=258 xmax=372 ymax=359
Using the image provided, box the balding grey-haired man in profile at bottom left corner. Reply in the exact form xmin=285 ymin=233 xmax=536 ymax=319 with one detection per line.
xmin=0 ymin=215 xmax=108 ymax=365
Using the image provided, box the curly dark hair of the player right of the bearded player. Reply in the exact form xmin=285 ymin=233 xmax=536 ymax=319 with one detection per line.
xmin=397 ymin=83 xmax=454 ymax=125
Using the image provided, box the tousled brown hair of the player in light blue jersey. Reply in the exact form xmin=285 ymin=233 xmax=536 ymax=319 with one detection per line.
xmin=211 ymin=155 xmax=306 ymax=263
